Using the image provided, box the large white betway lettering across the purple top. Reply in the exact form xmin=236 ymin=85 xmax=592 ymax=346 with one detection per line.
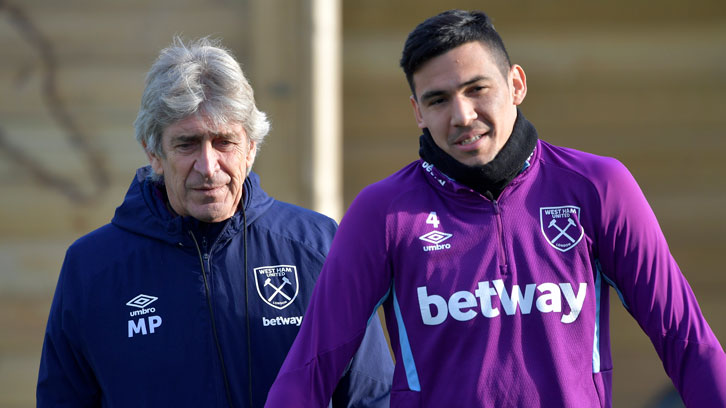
xmin=417 ymin=279 xmax=587 ymax=326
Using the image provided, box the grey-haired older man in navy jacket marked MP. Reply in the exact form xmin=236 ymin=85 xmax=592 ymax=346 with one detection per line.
xmin=37 ymin=39 xmax=392 ymax=407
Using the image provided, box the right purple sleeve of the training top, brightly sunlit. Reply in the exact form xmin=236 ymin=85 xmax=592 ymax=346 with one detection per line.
xmin=598 ymin=159 xmax=726 ymax=407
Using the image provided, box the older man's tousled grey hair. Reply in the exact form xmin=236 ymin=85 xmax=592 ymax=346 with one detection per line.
xmin=134 ymin=36 xmax=270 ymax=166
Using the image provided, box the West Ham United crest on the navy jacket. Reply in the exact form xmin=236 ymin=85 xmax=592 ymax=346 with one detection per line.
xmin=255 ymin=265 xmax=300 ymax=309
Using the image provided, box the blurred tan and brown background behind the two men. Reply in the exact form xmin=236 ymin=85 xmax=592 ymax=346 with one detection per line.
xmin=0 ymin=0 xmax=726 ymax=407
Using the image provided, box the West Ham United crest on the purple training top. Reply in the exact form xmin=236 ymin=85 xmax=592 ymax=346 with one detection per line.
xmin=539 ymin=205 xmax=585 ymax=252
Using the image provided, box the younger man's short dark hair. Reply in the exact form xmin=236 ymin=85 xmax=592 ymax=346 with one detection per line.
xmin=401 ymin=10 xmax=512 ymax=98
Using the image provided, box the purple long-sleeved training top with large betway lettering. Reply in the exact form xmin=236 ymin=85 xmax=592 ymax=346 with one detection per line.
xmin=266 ymin=140 xmax=726 ymax=408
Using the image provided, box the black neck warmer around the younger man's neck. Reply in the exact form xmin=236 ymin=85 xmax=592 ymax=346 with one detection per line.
xmin=419 ymin=109 xmax=537 ymax=199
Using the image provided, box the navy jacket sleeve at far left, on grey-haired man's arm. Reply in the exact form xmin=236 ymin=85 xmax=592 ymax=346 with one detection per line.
xmin=36 ymin=256 xmax=100 ymax=407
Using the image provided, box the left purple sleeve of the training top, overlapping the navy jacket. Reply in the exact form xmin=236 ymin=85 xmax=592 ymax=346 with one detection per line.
xmin=265 ymin=187 xmax=391 ymax=407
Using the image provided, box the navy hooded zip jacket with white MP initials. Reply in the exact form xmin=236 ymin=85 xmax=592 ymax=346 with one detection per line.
xmin=37 ymin=166 xmax=393 ymax=407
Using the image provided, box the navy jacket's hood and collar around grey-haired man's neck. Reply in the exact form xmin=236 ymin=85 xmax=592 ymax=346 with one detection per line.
xmin=111 ymin=166 xmax=274 ymax=245
